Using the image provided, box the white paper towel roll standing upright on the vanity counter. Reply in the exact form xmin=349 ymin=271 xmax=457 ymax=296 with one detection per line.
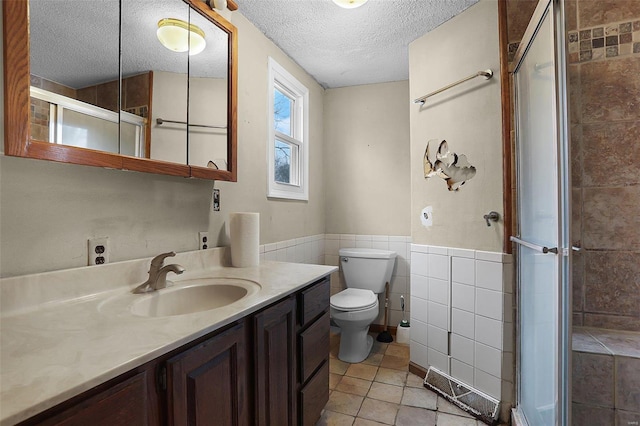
xmin=229 ymin=213 xmax=260 ymax=268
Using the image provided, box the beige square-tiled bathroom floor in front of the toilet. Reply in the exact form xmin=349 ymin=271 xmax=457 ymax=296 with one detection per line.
xmin=316 ymin=333 xmax=484 ymax=426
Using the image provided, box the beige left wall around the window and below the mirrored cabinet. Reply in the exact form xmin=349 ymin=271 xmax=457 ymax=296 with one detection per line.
xmin=0 ymin=12 xmax=325 ymax=276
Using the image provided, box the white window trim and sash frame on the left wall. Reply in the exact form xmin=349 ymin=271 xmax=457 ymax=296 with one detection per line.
xmin=267 ymin=57 xmax=309 ymax=201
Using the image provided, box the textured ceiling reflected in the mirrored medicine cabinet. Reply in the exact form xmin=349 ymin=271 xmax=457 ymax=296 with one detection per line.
xmin=29 ymin=0 xmax=228 ymax=89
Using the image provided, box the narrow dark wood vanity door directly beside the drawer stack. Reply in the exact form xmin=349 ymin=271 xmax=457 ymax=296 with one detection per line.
xmin=254 ymin=298 xmax=296 ymax=426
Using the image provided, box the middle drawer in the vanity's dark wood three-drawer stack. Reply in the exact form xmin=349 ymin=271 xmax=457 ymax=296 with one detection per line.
xmin=298 ymin=312 xmax=329 ymax=383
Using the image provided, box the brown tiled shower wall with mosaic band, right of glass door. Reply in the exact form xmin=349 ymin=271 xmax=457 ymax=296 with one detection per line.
xmin=566 ymin=0 xmax=640 ymax=331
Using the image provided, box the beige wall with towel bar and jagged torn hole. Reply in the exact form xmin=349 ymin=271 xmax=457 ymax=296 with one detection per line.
xmin=409 ymin=0 xmax=503 ymax=251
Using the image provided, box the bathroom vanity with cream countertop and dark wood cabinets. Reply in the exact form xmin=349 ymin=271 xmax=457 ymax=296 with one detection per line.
xmin=0 ymin=250 xmax=336 ymax=425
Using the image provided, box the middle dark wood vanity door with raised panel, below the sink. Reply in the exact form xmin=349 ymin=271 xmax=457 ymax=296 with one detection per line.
xmin=167 ymin=322 xmax=250 ymax=426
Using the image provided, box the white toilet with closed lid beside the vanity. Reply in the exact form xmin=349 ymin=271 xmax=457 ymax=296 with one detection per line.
xmin=331 ymin=248 xmax=396 ymax=363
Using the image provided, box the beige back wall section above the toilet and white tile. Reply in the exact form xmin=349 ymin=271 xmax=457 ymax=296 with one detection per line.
xmin=324 ymin=81 xmax=411 ymax=235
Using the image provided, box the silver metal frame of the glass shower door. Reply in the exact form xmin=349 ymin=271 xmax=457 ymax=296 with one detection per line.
xmin=510 ymin=0 xmax=572 ymax=426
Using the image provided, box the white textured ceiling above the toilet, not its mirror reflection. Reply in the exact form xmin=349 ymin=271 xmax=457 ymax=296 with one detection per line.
xmin=237 ymin=0 xmax=478 ymax=88
